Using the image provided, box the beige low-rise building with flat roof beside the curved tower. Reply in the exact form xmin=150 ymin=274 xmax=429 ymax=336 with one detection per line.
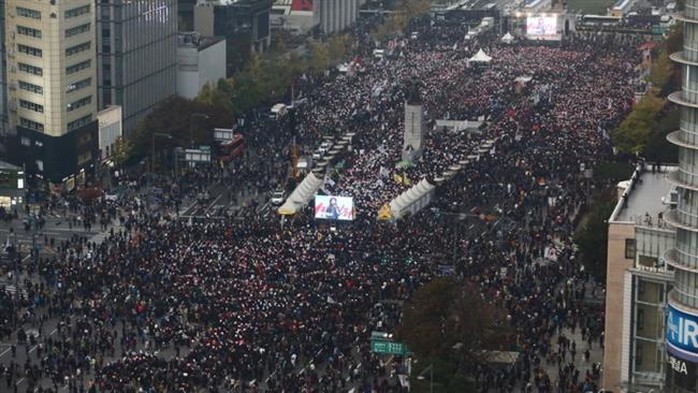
xmin=602 ymin=167 xmax=676 ymax=392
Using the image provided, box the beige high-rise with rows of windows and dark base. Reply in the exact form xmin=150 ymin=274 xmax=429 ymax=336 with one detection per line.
xmin=4 ymin=0 xmax=97 ymax=182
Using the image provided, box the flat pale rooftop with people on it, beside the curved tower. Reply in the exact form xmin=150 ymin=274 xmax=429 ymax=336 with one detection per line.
xmin=609 ymin=166 xmax=676 ymax=225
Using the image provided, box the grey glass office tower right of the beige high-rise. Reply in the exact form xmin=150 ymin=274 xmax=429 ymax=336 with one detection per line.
xmin=97 ymin=0 xmax=177 ymax=134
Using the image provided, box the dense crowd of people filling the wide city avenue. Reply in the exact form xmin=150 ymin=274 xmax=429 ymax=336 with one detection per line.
xmin=3 ymin=13 xmax=639 ymax=393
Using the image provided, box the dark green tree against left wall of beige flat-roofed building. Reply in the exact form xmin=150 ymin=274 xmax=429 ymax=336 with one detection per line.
xmin=574 ymin=202 xmax=615 ymax=282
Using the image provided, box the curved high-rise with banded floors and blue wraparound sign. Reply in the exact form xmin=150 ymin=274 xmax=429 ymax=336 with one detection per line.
xmin=664 ymin=0 xmax=698 ymax=392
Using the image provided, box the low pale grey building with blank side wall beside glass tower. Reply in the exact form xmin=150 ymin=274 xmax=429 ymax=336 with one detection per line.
xmin=177 ymin=32 xmax=226 ymax=99
